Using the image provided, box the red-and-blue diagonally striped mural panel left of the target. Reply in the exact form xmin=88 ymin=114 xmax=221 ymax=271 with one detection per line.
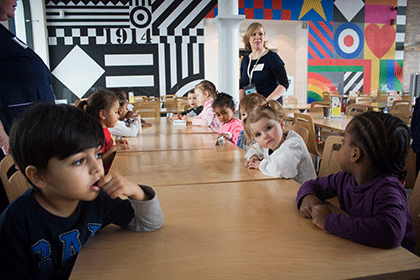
xmin=308 ymin=21 xmax=334 ymax=59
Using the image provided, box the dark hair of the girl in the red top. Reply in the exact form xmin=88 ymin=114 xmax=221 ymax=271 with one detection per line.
xmin=77 ymin=90 xmax=119 ymax=121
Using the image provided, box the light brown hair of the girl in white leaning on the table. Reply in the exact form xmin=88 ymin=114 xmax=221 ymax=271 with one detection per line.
xmin=244 ymin=100 xmax=285 ymax=143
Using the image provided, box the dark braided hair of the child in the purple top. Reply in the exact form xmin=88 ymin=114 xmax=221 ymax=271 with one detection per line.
xmin=346 ymin=112 xmax=410 ymax=181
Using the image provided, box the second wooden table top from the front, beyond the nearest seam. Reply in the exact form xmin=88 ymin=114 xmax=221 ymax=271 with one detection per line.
xmin=111 ymin=146 xmax=274 ymax=186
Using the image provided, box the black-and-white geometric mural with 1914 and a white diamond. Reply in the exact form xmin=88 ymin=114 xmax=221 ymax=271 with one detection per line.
xmin=46 ymin=0 xmax=217 ymax=102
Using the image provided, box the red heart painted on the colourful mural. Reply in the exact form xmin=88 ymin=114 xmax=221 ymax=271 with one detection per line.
xmin=365 ymin=24 xmax=395 ymax=59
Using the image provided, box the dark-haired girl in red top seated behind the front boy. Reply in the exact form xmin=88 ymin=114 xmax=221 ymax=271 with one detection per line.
xmin=77 ymin=90 xmax=129 ymax=172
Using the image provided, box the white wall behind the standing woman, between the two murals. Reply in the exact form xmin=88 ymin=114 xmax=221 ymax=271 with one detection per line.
xmin=204 ymin=19 xmax=308 ymax=103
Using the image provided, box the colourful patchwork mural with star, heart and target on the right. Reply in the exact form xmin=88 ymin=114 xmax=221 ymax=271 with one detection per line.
xmin=208 ymin=0 xmax=407 ymax=102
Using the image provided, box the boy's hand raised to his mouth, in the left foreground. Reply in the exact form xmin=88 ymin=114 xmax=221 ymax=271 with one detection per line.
xmin=97 ymin=172 xmax=149 ymax=200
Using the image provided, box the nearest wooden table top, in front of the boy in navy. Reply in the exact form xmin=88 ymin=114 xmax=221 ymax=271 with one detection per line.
xmin=70 ymin=179 xmax=420 ymax=279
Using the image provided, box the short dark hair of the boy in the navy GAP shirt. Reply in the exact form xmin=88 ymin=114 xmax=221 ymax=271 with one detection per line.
xmin=10 ymin=103 xmax=105 ymax=174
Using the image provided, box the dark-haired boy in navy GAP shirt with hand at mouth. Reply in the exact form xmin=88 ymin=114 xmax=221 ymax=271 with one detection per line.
xmin=0 ymin=104 xmax=163 ymax=279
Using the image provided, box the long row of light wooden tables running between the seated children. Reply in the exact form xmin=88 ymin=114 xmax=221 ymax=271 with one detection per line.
xmin=70 ymin=119 xmax=420 ymax=279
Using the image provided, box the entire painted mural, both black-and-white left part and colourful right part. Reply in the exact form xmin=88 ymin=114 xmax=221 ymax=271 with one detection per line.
xmin=46 ymin=0 xmax=407 ymax=102
